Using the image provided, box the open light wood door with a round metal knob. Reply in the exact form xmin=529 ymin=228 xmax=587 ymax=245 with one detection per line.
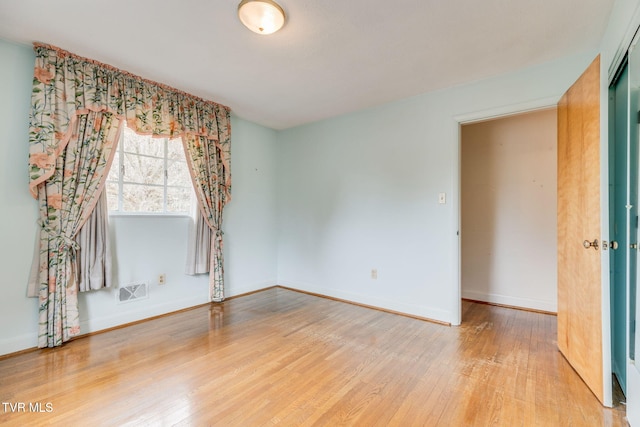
xmin=558 ymin=57 xmax=605 ymax=403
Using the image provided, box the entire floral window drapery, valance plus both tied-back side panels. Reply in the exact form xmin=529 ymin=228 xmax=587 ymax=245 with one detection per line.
xmin=29 ymin=43 xmax=231 ymax=347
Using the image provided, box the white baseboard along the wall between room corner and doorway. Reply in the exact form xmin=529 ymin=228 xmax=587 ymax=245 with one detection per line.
xmin=278 ymin=280 xmax=453 ymax=323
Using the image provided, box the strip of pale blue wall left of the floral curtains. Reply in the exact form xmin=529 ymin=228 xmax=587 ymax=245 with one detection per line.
xmin=0 ymin=40 xmax=38 ymax=354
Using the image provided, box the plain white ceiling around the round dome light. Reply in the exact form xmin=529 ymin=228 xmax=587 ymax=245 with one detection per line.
xmin=0 ymin=0 xmax=614 ymax=129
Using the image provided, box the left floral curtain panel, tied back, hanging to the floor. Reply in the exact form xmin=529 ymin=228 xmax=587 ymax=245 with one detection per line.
xmin=32 ymin=111 xmax=120 ymax=347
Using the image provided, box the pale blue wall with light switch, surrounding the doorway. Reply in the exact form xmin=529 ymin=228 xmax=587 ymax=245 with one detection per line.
xmin=278 ymin=51 xmax=597 ymax=324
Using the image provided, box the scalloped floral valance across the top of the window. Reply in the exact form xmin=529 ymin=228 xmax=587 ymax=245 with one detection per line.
xmin=29 ymin=43 xmax=231 ymax=201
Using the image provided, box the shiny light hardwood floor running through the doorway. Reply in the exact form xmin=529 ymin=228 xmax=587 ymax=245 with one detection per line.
xmin=0 ymin=288 xmax=626 ymax=426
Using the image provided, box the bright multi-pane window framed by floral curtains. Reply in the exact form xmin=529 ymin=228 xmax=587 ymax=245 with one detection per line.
xmin=106 ymin=126 xmax=194 ymax=214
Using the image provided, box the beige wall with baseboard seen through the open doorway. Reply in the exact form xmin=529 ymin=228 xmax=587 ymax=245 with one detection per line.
xmin=460 ymin=107 xmax=557 ymax=320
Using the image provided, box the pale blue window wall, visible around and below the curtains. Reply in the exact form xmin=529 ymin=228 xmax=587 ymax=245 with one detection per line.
xmin=0 ymin=39 xmax=277 ymax=354
